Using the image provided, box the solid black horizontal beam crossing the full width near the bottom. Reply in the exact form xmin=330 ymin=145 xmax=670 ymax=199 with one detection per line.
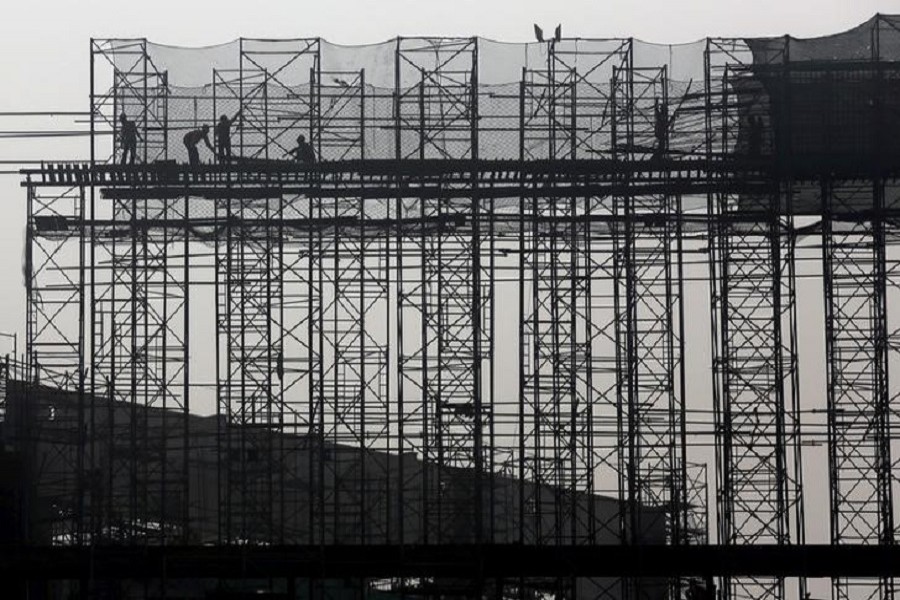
xmin=0 ymin=544 xmax=900 ymax=581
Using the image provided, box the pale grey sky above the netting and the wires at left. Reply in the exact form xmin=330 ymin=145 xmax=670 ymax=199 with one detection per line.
xmin=0 ymin=0 xmax=900 ymax=110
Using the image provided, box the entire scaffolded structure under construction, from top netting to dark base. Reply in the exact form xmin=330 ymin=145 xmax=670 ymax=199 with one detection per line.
xmin=8 ymin=15 xmax=900 ymax=600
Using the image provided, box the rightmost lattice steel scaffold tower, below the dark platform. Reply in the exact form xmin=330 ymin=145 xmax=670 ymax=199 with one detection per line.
xmin=821 ymin=180 xmax=894 ymax=598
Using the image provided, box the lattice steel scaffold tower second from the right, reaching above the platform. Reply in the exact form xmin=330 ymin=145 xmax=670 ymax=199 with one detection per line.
xmin=706 ymin=40 xmax=805 ymax=598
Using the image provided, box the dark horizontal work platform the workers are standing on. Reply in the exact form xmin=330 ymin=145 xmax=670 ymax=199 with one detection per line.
xmin=20 ymin=155 xmax=900 ymax=187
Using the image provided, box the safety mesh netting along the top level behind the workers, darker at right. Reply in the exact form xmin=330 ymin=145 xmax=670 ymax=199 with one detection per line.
xmin=95 ymin=15 xmax=900 ymax=190
